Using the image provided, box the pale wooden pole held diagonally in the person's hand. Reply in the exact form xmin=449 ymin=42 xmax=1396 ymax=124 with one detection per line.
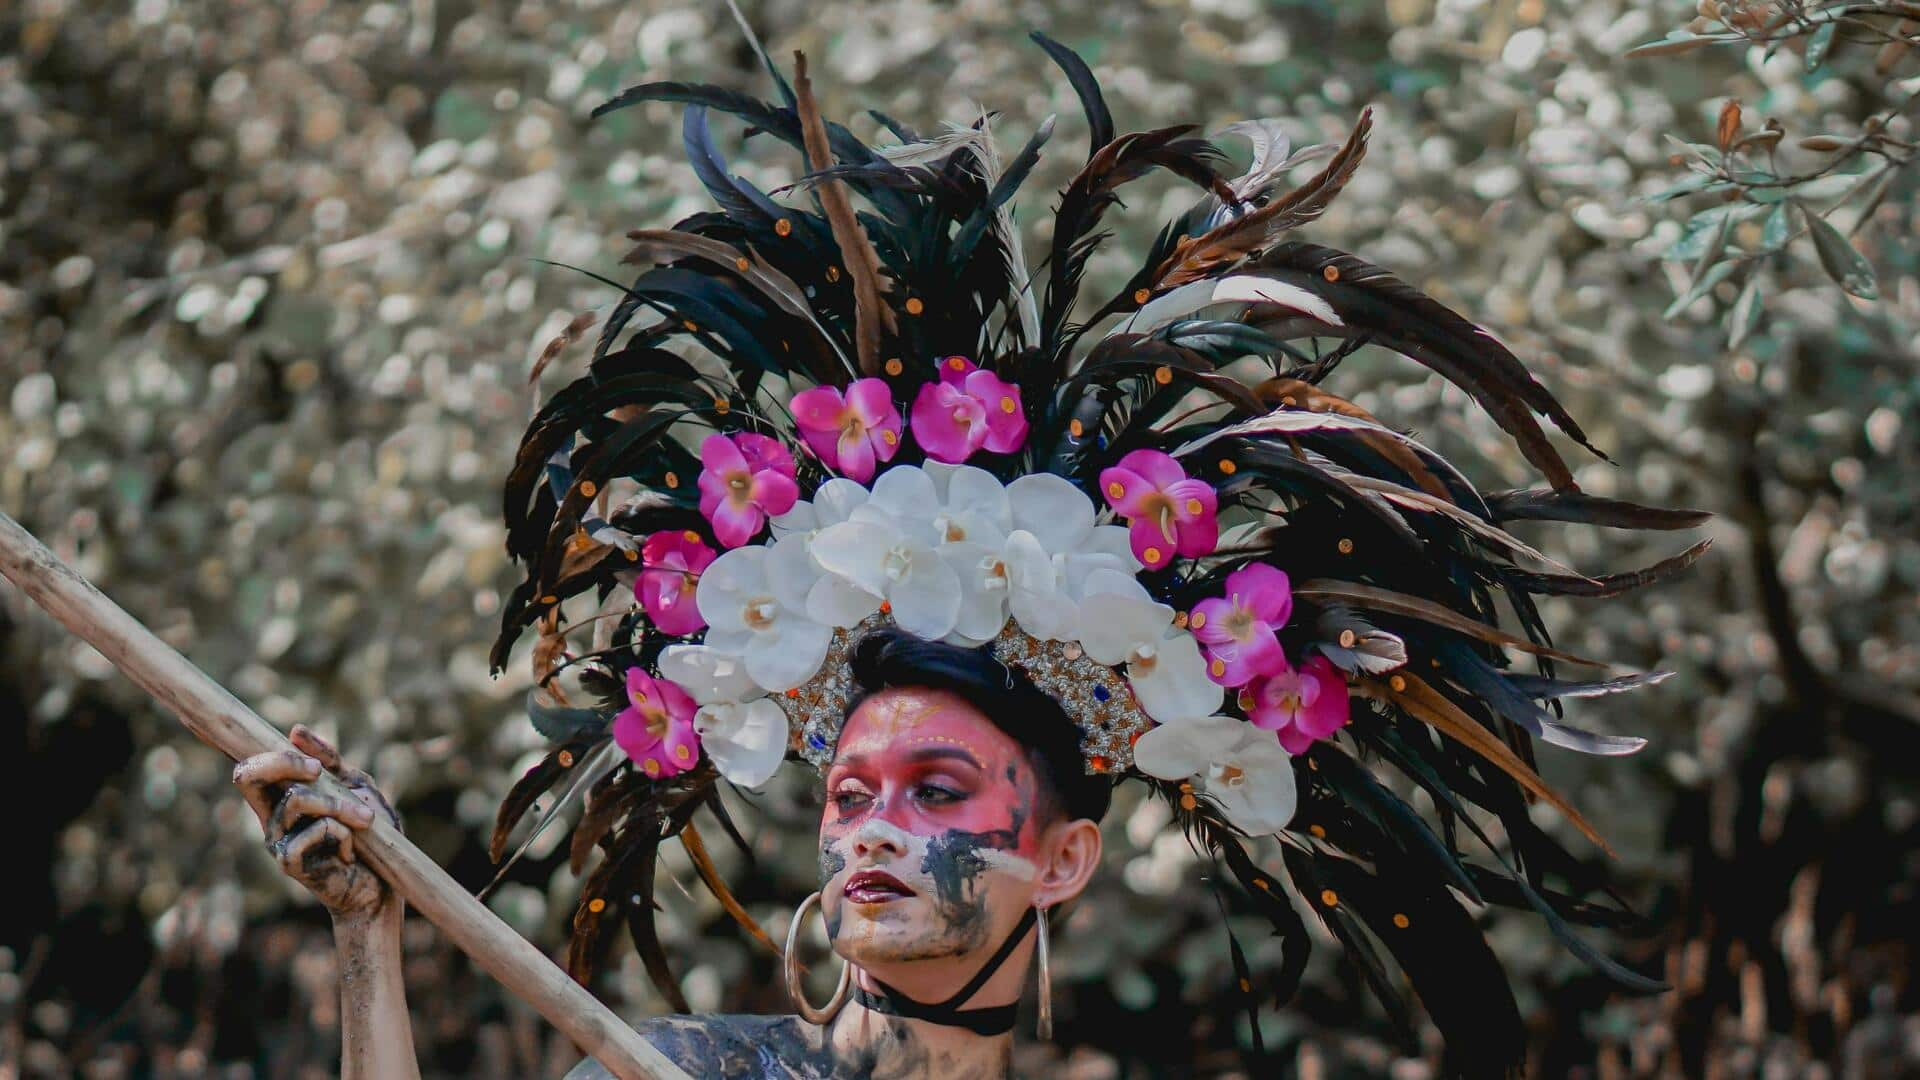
xmin=0 ymin=513 xmax=687 ymax=1080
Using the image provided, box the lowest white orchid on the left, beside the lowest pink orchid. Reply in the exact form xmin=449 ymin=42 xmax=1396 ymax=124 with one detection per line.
xmin=660 ymin=646 xmax=787 ymax=788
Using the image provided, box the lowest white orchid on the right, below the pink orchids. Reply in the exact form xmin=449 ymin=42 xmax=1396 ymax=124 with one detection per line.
xmin=1133 ymin=717 xmax=1298 ymax=836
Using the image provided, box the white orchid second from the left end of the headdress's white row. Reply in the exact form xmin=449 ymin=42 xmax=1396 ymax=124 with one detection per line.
xmin=693 ymin=546 xmax=833 ymax=690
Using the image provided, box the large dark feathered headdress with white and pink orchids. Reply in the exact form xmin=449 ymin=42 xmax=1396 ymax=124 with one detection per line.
xmin=493 ymin=35 xmax=1705 ymax=1074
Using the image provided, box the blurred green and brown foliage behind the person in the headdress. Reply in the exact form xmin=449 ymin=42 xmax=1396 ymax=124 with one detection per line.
xmin=0 ymin=0 xmax=1920 ymax=1078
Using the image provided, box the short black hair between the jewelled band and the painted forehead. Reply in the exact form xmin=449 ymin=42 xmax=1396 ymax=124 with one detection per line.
xmin=847 ymin=628 xmax=1114 ymax=821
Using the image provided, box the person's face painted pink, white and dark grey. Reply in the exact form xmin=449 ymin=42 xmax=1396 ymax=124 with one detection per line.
xmin=820 ymin=688 xmax=1043 ymax=982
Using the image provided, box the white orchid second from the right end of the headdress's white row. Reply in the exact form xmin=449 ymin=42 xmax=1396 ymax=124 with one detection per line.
xmin=1075 ymin=569 xmax=1227 ymax=724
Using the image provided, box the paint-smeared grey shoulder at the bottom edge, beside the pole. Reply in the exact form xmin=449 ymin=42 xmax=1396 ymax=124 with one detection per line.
xmin=566 ymin=1017 xmax=835 ymax=1080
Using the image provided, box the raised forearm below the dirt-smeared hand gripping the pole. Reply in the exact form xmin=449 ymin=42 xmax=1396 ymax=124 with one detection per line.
xmin=334 ymin=899 xmax=420 ymax=1080
